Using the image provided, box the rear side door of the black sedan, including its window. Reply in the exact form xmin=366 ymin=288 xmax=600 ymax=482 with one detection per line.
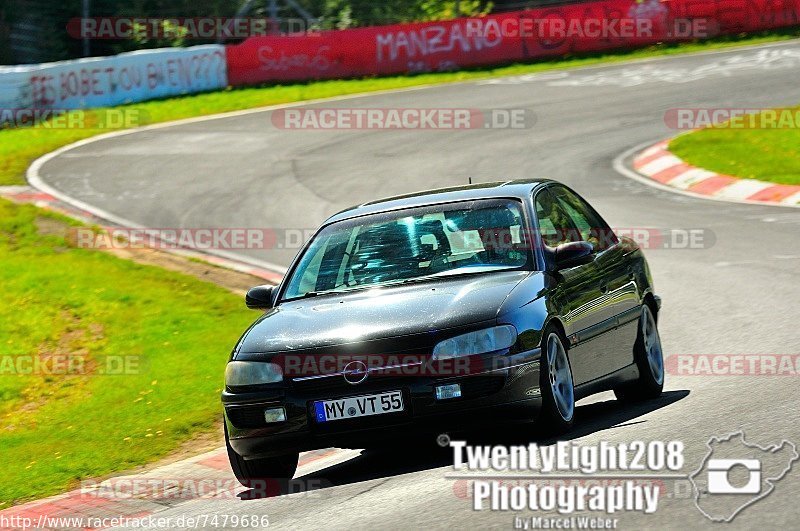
xmin=552 ymin=186 xmax=640 ymax=376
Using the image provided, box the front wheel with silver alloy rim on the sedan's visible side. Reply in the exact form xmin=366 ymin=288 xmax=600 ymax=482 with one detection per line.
xmin=539 ymin=327 xmax=575 ymax=435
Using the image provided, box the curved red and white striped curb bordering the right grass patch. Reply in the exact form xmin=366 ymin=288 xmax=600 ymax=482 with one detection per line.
xmin=633 ymin=140 xmax=800 ymax=206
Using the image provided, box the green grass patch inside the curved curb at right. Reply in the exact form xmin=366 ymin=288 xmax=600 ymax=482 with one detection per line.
xmin=669 ymin=107 xmax=800 ymax=185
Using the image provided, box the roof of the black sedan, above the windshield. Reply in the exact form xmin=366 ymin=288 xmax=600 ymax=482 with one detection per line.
xmin=325 ymin=179 xmax=556 ymax=225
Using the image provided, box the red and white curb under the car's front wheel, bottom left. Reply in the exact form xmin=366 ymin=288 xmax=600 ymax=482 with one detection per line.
xmin=0 ymin=447 xmax=360 ymax=530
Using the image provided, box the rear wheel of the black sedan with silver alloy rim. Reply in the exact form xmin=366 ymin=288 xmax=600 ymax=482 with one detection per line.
xmin=614 ymin=303 xmax=664 ymax=402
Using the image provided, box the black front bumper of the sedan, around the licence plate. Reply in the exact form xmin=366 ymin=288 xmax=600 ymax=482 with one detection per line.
xmin=222 ymin=349 xmax=541 ymax=459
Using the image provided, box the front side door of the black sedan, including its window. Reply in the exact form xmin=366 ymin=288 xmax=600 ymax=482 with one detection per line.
xmin=534 ymin=189 xmax=603 ymax=385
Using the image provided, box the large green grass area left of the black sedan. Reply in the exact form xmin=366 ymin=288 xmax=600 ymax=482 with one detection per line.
xmin=0 ymin=200 xmax=253 ymax=508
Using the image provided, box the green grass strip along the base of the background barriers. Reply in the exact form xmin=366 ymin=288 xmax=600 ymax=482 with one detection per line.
xmin=0 ymin=28 xmax=800 ymax=185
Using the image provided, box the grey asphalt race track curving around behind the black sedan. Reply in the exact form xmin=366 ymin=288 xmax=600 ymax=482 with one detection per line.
xmin=34 ymin=42 xmax=800 ymax=529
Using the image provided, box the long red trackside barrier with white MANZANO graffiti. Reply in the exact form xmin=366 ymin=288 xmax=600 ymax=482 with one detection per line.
xmin=226 ymin=0 xmax=800 ymax=86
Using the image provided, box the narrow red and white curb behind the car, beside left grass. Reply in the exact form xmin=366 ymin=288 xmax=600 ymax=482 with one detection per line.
xmin=0 ymin=186 xmax=283 ymax=284
